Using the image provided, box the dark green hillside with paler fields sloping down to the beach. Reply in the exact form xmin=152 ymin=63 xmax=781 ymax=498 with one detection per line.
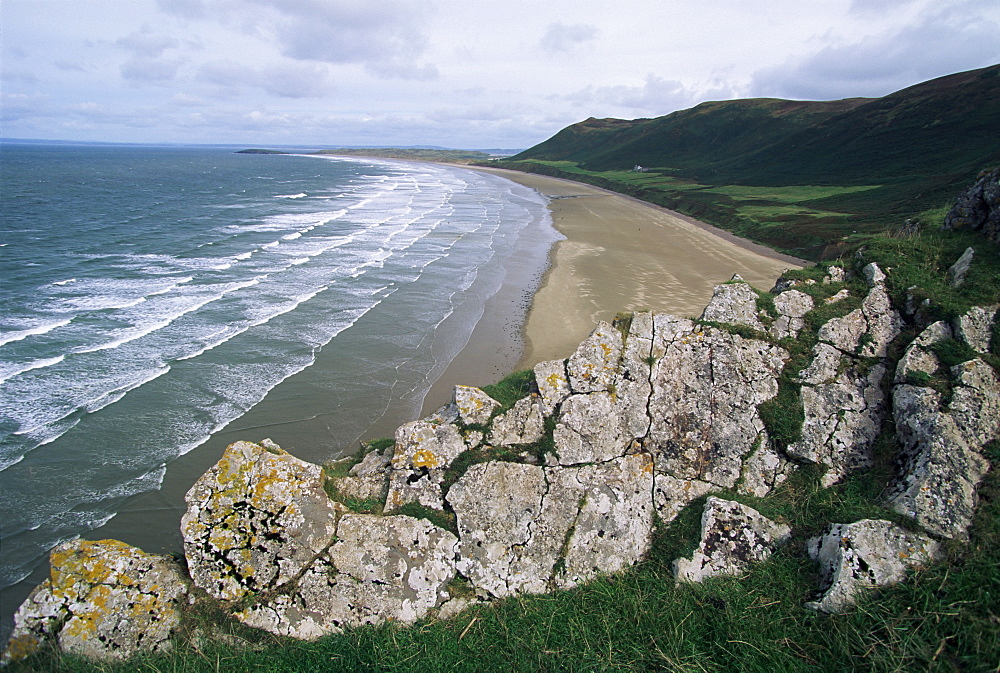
xmin=490 ymin=65 xmax=1000 ymax=260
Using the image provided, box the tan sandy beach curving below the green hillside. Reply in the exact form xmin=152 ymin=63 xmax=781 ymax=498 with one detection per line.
xmin=454 ymin=168 xmax=803 ymax=370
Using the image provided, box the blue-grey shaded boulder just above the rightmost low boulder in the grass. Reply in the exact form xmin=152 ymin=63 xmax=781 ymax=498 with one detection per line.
xmin=889 ymin=385 xmax=988 ymax=538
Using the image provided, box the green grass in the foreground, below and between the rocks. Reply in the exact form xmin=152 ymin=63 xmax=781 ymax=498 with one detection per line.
xmin=8 ymin=213 xmax=1000 ymax=673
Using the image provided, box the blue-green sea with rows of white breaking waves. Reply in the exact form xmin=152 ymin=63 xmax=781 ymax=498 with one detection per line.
xmin=0 ymin=143 xmax=558 ymax=634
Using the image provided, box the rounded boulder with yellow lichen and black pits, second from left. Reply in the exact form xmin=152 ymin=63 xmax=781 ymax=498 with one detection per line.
xmin=181 ymin=442 xmax=337 ymax=600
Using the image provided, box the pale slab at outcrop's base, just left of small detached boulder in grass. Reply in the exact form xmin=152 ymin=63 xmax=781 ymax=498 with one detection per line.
xmin=548 ymin=453 xmax=653 ymax=588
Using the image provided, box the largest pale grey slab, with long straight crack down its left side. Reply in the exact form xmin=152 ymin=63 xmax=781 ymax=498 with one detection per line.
xmin=645 ymin=315 xmax=788 ymax=488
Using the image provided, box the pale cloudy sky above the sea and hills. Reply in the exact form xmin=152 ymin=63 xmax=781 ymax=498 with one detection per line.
xmin=0 ymin=0 xmax=1000 ymax=149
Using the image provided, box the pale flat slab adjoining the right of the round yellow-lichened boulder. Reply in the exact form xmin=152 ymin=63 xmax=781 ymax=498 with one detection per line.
xmin=236 ymin=514 xmax=458 ymax=640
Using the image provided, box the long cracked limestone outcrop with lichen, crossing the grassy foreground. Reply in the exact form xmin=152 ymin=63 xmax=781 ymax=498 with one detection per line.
xmin=4 ymin=264 xmax=1000 ymax=660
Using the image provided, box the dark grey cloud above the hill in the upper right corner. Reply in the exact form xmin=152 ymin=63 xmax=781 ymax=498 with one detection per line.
xmin=750 ymin=2 xmax=1000 ymax=100
